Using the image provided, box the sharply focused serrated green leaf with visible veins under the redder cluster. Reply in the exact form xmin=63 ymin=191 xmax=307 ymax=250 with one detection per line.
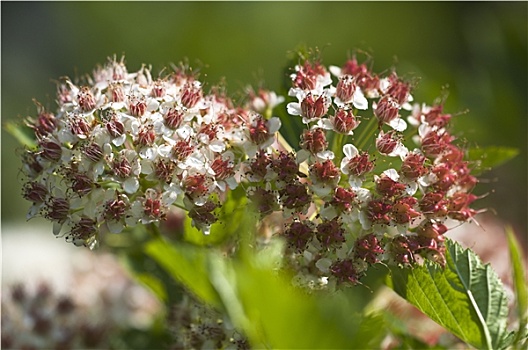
xmin=391 ymin=240 xmax=508 ymax=349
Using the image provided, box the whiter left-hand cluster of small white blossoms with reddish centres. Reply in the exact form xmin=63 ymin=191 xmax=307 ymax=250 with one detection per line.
xmin=23 ymin=58 xmax=283 ymax=248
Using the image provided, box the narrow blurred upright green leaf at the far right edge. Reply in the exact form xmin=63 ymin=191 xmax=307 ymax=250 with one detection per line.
xmin=506 ymin=227 xmax=528 ymax=344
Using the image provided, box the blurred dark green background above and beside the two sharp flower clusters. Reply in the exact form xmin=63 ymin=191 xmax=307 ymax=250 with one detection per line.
xmin=1 ymin=2 xmax=528 ymax=235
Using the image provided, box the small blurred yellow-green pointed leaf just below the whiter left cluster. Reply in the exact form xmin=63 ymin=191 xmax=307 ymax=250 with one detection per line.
xmin=145 ymin=238 xmax=221 ymax=307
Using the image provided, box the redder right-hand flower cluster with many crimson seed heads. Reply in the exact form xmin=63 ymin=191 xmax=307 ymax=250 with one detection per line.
xmin=266 ymin=54 xmax=477 ymax=286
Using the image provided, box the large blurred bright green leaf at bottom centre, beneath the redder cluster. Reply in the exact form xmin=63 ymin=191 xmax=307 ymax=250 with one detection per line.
xmin=211 ymin=256 xmax=385 ymax=349
